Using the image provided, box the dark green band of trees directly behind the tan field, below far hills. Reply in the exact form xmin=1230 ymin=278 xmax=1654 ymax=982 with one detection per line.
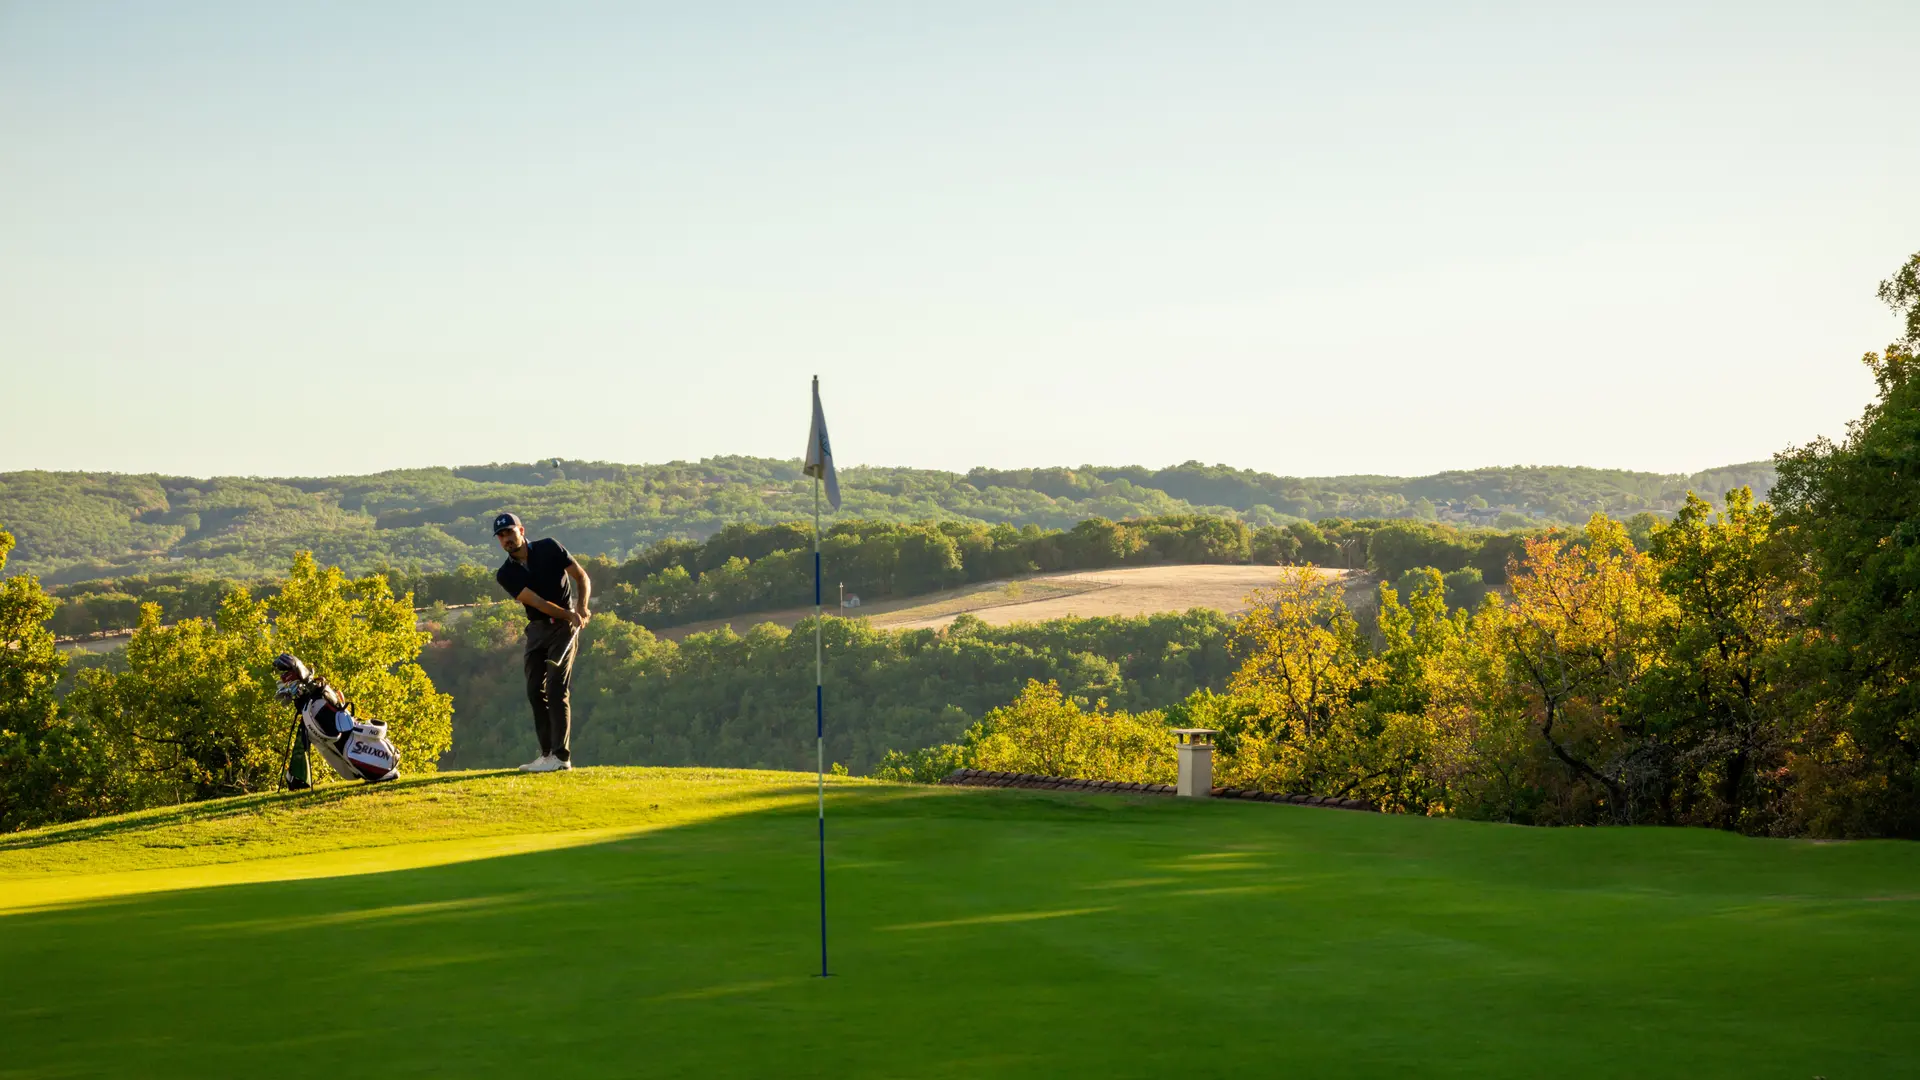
xmin=52 ymin=515 xmax=1543 ymax=636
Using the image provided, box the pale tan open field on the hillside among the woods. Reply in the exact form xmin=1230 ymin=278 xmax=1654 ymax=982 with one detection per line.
xmin=660 ymin=563 xmax=1342 ymax=640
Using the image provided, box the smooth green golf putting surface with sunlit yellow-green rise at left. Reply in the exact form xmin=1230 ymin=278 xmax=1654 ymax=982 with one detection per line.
xmin=0 ymin=769 xmax=1920 ymax=1080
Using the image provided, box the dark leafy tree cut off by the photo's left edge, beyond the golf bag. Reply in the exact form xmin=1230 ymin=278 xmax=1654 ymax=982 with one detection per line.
xmin=0 ymin=530 xmax=113 ymax=832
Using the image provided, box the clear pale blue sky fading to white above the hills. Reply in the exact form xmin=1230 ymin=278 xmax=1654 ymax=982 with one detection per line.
xmin=0 ymin=0 xmax=1920 ymax=477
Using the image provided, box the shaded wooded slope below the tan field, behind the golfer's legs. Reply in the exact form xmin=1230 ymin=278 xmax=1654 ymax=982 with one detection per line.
xmin=420 ymin=603 xmax=1233 ymax=773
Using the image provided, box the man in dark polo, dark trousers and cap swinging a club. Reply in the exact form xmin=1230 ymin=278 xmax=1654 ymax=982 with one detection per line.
xmin=493 ymin=513 xmax=591 ymax=773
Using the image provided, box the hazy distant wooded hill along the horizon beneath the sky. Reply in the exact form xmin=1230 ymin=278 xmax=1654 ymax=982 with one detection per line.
xmin=0 ymin=457 xmax=1774 ymax=584
